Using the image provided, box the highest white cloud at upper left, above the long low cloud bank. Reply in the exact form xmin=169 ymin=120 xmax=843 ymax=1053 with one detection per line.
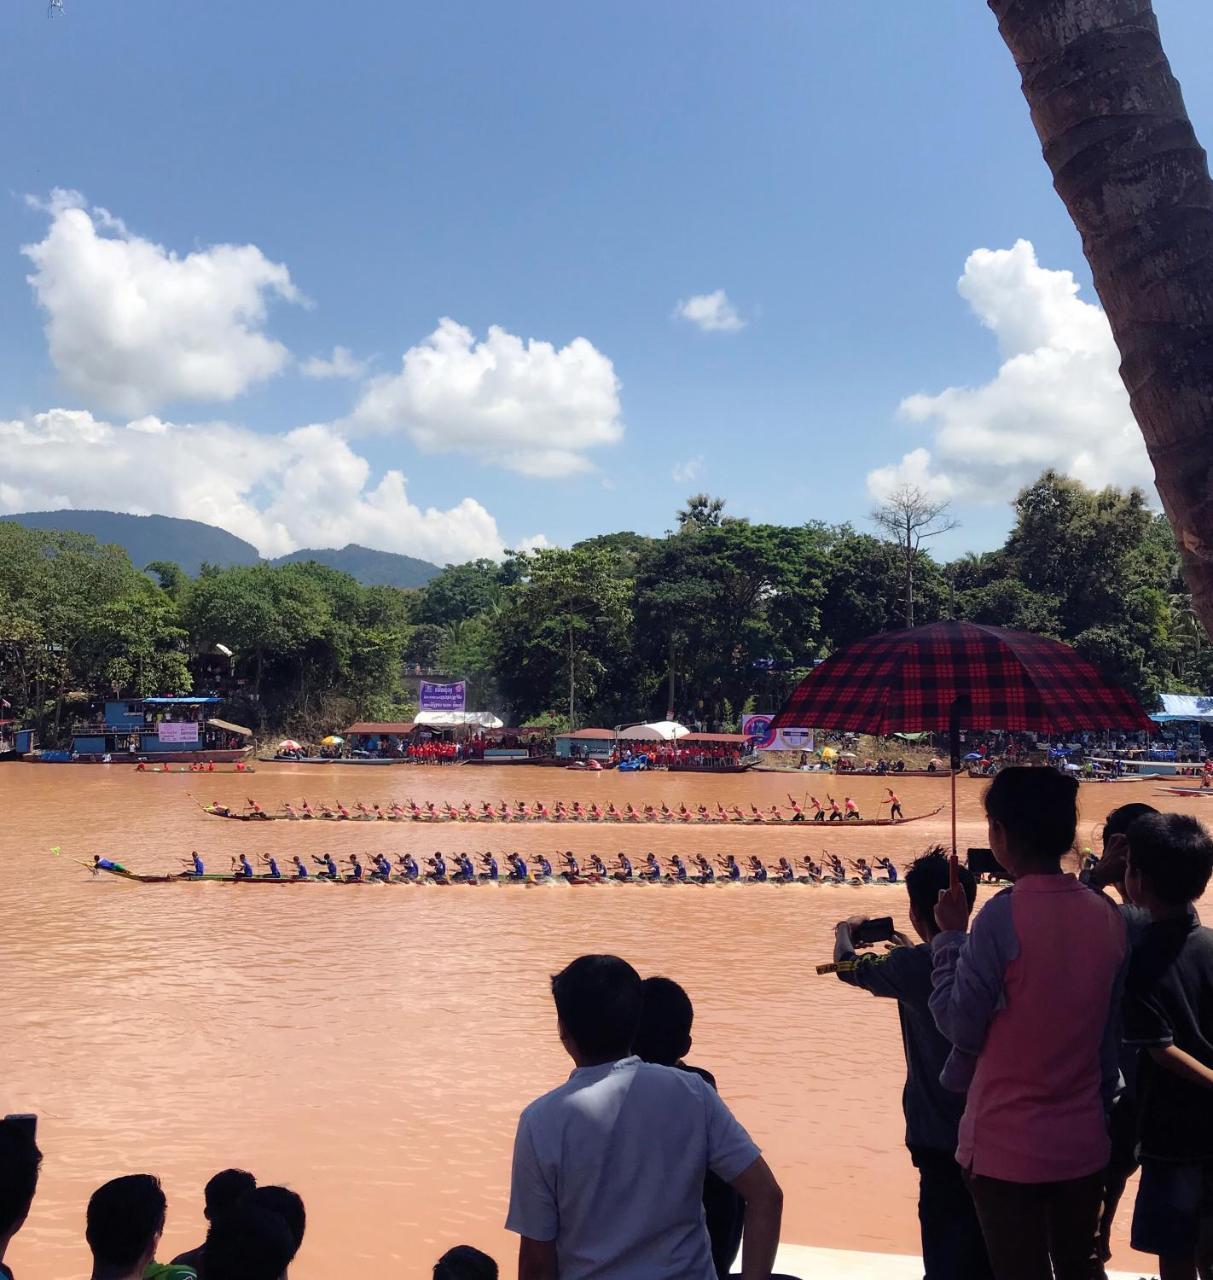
xmin=22 ymin=191 xmax=306 ymax=415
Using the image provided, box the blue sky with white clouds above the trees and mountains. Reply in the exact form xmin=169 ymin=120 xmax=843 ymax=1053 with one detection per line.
xmin=0 ymin=0 xmax=1213 ymax=559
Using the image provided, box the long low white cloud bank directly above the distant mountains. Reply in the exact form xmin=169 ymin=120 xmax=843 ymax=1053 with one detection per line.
xmin=0 ymin=410 xmax=529 ymax=564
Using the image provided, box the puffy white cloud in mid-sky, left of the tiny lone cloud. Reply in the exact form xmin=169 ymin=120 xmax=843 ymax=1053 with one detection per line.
xmin=343 ymin=317 xmax=623 ymax=476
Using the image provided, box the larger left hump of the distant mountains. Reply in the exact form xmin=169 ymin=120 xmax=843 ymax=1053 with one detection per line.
xmin=0 ymin=511 xmax=261 ymax=575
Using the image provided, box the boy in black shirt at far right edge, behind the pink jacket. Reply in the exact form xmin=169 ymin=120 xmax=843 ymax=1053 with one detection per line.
xmin=1125 ymin=813 xmax=1213 ymax=1280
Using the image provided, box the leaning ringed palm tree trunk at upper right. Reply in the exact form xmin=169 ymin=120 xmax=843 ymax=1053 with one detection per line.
xmin=988 ymin=0 xmax=1213 ymax=630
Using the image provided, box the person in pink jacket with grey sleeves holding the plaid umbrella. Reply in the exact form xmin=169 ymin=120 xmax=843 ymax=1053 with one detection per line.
xmin=930 ymin=768 xmax=1129 ymax=1280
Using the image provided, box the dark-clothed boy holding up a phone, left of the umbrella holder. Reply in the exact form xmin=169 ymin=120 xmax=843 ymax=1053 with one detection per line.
xmin=834 ymin=846 xmax=992 ymax=1280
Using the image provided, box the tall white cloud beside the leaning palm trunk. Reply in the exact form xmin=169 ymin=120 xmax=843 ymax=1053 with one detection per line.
xmin=868 ymin=239 xmax=1153 ymax=502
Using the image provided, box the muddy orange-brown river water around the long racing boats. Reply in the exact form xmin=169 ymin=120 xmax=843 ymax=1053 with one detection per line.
xmin=0 ymin=764 xmax=1192 ymax=1280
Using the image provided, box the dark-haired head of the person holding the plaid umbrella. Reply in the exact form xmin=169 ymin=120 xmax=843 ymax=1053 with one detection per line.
xmin=985 ymin=765 xmax=1079 ymax=879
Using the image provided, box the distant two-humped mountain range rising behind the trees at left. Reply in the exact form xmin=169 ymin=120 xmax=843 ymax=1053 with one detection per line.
xmin=0 ymin=511 xmax=439 ymax=588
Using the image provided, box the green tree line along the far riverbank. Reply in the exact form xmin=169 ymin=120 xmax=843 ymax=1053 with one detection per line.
xmin=0 ymin=471 xmax=1213 ymax=741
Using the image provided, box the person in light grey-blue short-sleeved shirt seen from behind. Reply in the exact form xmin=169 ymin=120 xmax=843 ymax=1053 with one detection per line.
xmin=505 ymin=955 xmax=783 ymax=1280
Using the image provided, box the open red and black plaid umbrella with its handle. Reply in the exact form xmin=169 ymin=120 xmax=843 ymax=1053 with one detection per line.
xmin=772 ymin=622 xmax=1153 ymax=852
